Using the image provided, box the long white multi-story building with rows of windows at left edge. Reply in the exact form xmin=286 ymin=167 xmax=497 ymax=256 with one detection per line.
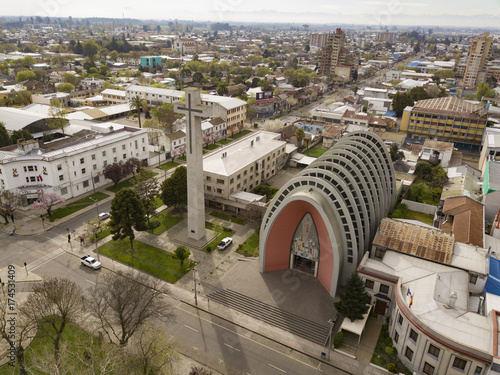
xmin=0 ymin=124 xmax=149 ymax=205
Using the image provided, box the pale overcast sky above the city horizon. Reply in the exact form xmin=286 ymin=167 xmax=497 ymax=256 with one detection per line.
xmin=0 ymin=0 xmax=500 ymax=27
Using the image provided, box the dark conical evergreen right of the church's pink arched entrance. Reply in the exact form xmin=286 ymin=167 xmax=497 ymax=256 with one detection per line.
xmin=334 ymin=272 xmax=370 ymax=322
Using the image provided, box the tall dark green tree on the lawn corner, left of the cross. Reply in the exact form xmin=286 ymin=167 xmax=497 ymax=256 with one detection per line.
xmin=109 ymin=188 xmax=146 ymax=252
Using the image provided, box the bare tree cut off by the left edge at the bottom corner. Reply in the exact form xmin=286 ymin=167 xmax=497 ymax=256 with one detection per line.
xmin=0 ymin=283 xmax=36 ymax=375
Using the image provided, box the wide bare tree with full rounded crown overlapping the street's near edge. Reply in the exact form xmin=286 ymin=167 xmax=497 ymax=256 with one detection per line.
xmin=89 ymin=272 xmax=173 ymax=346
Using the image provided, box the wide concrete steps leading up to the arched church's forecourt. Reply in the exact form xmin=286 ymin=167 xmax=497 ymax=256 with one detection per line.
xmin=207 ymin=289 xmax=329 ymax=345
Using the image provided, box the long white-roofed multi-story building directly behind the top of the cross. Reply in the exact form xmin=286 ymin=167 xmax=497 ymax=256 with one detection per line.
xmin=125 ymin=85 xmax=247 ymax=132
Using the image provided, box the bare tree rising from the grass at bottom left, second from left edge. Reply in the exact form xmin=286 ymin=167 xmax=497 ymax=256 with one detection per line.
xmin=19 ymin=278 xmax=84 ymax=368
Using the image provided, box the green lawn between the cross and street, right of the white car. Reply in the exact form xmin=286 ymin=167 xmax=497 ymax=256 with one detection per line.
xmin=99 ymin=238 xmax=190 ymax=284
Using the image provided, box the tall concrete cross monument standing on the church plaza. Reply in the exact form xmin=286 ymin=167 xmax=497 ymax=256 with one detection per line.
xmin=174 ymin=88 xmax=212 ymax=241
